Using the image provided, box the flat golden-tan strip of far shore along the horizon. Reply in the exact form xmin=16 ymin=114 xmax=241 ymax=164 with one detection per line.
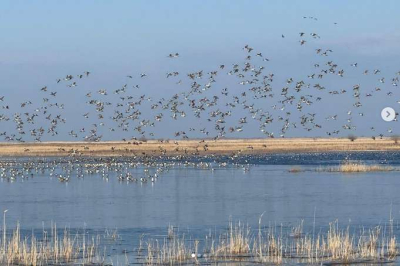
xmin=0 ymin=138 xmax=400 ymax=157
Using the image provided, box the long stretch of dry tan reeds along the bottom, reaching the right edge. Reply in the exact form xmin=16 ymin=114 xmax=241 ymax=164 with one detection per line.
xmin=141 ymin=218 xmax=398 ymax=265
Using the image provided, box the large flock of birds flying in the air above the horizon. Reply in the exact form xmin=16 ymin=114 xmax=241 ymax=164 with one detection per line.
xmin=0 ymin=17 xmax=400 ymax=142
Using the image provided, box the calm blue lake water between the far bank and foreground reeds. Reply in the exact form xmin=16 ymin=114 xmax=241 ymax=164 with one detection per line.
xmin=0 ymin=153 xmax=400 ymax=264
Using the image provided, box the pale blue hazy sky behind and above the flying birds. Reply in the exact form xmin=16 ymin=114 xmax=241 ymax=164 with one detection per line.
xmin=0 ymin=0 xmax=400 ymax=140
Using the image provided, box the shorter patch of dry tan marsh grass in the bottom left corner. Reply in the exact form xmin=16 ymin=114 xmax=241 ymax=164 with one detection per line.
xmin=0 ymin=216 xmax=104 ymax=266
